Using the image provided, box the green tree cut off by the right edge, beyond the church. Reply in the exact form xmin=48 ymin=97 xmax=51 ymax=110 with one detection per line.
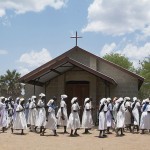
xmin=139 ymin=55 xmax=150 ymax=98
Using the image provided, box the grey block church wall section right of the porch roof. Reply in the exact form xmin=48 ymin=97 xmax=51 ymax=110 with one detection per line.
xmin=98 ymin=61 xmax=138 ymax=97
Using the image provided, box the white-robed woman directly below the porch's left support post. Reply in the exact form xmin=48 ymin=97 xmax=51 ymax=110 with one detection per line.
xmin=27 ymin=95 xmax=37 ymax=132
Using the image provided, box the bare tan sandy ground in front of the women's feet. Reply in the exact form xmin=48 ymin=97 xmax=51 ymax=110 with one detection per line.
xmin=0 ymin=128 xmax=150 ymax=150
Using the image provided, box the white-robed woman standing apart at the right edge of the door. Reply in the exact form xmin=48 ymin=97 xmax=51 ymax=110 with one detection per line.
xmin=82 ymin=98 xmax=93 ymax=134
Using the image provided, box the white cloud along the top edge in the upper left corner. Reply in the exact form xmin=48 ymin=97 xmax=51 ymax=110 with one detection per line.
xmin=0 ymin=0 xmax=68 ymax=17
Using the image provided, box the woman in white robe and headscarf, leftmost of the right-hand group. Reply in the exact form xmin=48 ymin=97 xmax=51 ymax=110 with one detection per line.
xmin=98 ymin=98 xmax=107 ymax=138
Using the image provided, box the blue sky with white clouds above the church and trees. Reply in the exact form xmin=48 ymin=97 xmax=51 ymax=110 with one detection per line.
xmin=0 ymin=0 xmax=150 ymax=75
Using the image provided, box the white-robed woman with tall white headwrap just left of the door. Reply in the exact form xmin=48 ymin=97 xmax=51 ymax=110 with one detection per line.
xmin=57 ymin=95 xmax=68 ymax=133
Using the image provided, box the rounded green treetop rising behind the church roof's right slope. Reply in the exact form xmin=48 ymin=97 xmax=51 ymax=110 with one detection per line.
xmin=103 ymin=53 xmax=135 ymax=72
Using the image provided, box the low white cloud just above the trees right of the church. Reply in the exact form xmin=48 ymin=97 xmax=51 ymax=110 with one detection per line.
xmin=100 ymin=42 xmax=150 ymax=68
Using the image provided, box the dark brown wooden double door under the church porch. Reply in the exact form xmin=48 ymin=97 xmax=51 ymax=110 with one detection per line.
xmin=65 ymin=81 xmax=89 ymax=119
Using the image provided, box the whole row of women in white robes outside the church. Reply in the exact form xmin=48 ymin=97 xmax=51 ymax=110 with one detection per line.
xmin=0 ymin=93 xmax=150 ymax=138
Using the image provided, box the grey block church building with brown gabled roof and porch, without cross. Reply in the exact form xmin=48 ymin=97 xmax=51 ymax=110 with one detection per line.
xmin=20 ymin=46 xmax=144 ymax=123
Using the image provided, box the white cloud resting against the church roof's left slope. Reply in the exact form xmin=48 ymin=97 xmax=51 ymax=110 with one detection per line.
xmin=18 ymin=48 xmax=52 ymax=75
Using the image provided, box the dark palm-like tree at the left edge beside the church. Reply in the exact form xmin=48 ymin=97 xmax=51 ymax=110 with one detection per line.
xmin=0 ymin=70 xmax=20 ymax=97
